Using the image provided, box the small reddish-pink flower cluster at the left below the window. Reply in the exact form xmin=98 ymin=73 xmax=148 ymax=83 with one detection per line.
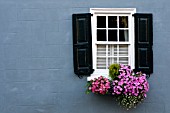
xmin=87 ymin=76 xmax=110 ymax=95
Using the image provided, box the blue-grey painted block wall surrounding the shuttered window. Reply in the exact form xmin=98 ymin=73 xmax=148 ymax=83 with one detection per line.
xmin=0 ymin=0 xmax=170 ymax=113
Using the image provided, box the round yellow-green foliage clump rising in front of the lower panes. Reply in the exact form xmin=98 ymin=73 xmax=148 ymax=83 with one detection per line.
xmin=109 ymin=64 xmax=120 ymax=80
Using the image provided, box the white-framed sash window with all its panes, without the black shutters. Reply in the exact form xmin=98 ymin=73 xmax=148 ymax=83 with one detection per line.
xmin=89 ymin=8 xmax=136 ymax=79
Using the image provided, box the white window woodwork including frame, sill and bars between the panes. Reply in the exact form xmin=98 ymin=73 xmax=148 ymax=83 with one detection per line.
xmin=87 ymin=8 xmax=136 ymax=81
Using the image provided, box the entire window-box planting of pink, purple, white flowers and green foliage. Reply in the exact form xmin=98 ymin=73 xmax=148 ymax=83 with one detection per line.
xmin=87 ymin=64 xmax=149 ymax=109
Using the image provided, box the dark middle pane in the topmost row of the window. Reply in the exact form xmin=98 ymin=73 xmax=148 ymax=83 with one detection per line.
xmin=108 ymin=16 xmax=117 ymax=28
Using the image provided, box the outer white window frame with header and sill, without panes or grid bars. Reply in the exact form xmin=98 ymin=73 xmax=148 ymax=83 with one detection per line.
xmin=87 ymin=8 xmax=136 ymax=81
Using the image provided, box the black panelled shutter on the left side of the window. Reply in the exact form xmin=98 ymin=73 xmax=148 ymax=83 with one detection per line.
xmin=72 ymin=13 xmax=93 ymax=77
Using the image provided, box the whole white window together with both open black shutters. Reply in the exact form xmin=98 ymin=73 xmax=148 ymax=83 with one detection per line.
xmin=73 ymin=8 xmax=153 ymax=80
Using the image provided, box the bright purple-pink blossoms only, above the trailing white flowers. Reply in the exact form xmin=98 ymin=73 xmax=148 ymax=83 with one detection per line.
xmin=112 ymin=65 xmax=149 ymax=97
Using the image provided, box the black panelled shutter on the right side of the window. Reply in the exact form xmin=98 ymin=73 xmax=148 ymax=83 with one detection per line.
xmin=134 ymin=13 xmax=153 ymax=75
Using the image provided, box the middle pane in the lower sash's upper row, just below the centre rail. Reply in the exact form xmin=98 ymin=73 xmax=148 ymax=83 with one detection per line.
xmin=108 ymin=45 xmax=118 ymax=56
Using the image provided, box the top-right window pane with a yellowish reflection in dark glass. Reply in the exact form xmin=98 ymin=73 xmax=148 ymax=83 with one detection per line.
xmin=119 ymin=16 xmax=128 ymax=28
